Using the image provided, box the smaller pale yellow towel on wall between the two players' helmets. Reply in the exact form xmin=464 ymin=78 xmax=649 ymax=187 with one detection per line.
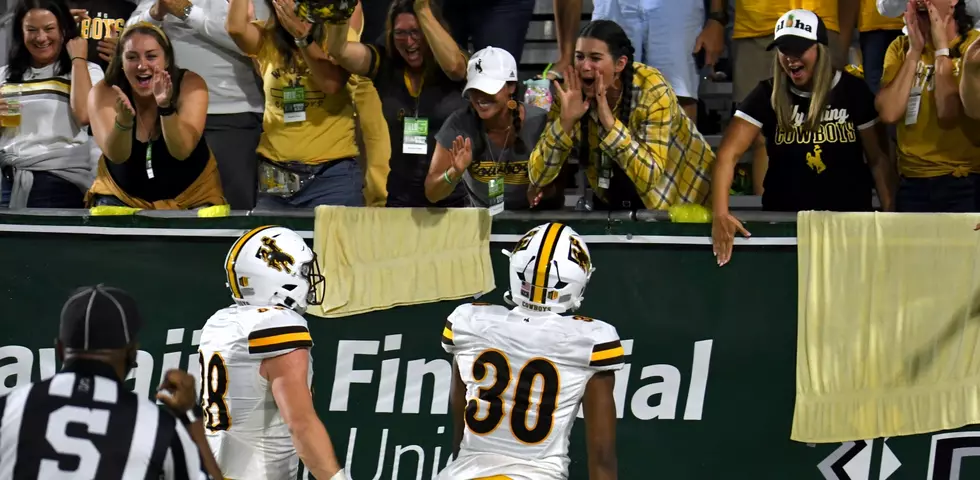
xmin=309 ymin=206 xmax=494 ymax=318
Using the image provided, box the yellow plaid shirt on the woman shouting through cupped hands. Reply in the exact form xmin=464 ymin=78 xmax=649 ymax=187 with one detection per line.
xmin=528 ymin=63 xmax=715 ymax=210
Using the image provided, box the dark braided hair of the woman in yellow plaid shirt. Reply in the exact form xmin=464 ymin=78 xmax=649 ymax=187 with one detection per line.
xmin=578 ymin=20 xmax=635 ymax=165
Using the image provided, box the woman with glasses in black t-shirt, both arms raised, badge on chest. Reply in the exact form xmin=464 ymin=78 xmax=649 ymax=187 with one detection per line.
xmin=327 ymin=0 xmax=467 ymax=207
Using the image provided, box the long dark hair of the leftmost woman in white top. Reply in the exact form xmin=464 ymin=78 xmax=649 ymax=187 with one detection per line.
xmin=7 ymin=0 xmax=78 ymax=83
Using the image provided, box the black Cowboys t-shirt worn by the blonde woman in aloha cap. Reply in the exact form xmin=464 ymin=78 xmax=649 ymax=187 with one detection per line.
xmin=735 ymin=72 xmax=878 ymax=212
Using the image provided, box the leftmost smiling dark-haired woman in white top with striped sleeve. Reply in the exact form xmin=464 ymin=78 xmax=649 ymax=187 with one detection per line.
xmin=0 ymin=0 xmax=102 ymax=208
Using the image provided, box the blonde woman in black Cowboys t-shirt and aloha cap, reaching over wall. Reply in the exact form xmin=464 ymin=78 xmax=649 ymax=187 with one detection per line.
xmin=711 ymin=10 xmax=894 ymax=265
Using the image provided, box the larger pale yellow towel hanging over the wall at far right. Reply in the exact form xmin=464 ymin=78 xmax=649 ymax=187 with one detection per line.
xmin=791 ymin=212 xmax=980 ymax=443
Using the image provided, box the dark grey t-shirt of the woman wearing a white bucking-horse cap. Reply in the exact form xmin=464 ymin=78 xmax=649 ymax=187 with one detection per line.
xmin=436 ymin=104 xmax=548 ymax=210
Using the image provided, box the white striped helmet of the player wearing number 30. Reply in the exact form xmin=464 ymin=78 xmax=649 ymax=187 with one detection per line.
xmin=503 ymin=222 xmax=595 ymax=313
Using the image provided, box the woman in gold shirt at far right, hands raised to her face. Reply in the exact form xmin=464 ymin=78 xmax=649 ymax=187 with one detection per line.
xmin=876 ymin=0 xmax=980 ymax=212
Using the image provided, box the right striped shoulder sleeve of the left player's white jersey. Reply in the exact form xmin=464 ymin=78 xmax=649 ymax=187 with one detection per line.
xmin=248 ymin=308 xmax=313 ymax=358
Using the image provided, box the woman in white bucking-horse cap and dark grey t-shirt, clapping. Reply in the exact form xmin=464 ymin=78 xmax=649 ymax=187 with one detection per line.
xmin=425 ymin=47 xmax=563 ymax=215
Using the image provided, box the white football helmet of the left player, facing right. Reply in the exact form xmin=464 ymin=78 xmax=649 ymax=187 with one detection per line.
xmin=225 ymin=225 xmax=323 ymax=314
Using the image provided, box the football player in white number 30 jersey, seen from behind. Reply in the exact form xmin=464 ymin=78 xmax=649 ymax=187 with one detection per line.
xmin=438 ymin=223 xmax=624 ymax=480
